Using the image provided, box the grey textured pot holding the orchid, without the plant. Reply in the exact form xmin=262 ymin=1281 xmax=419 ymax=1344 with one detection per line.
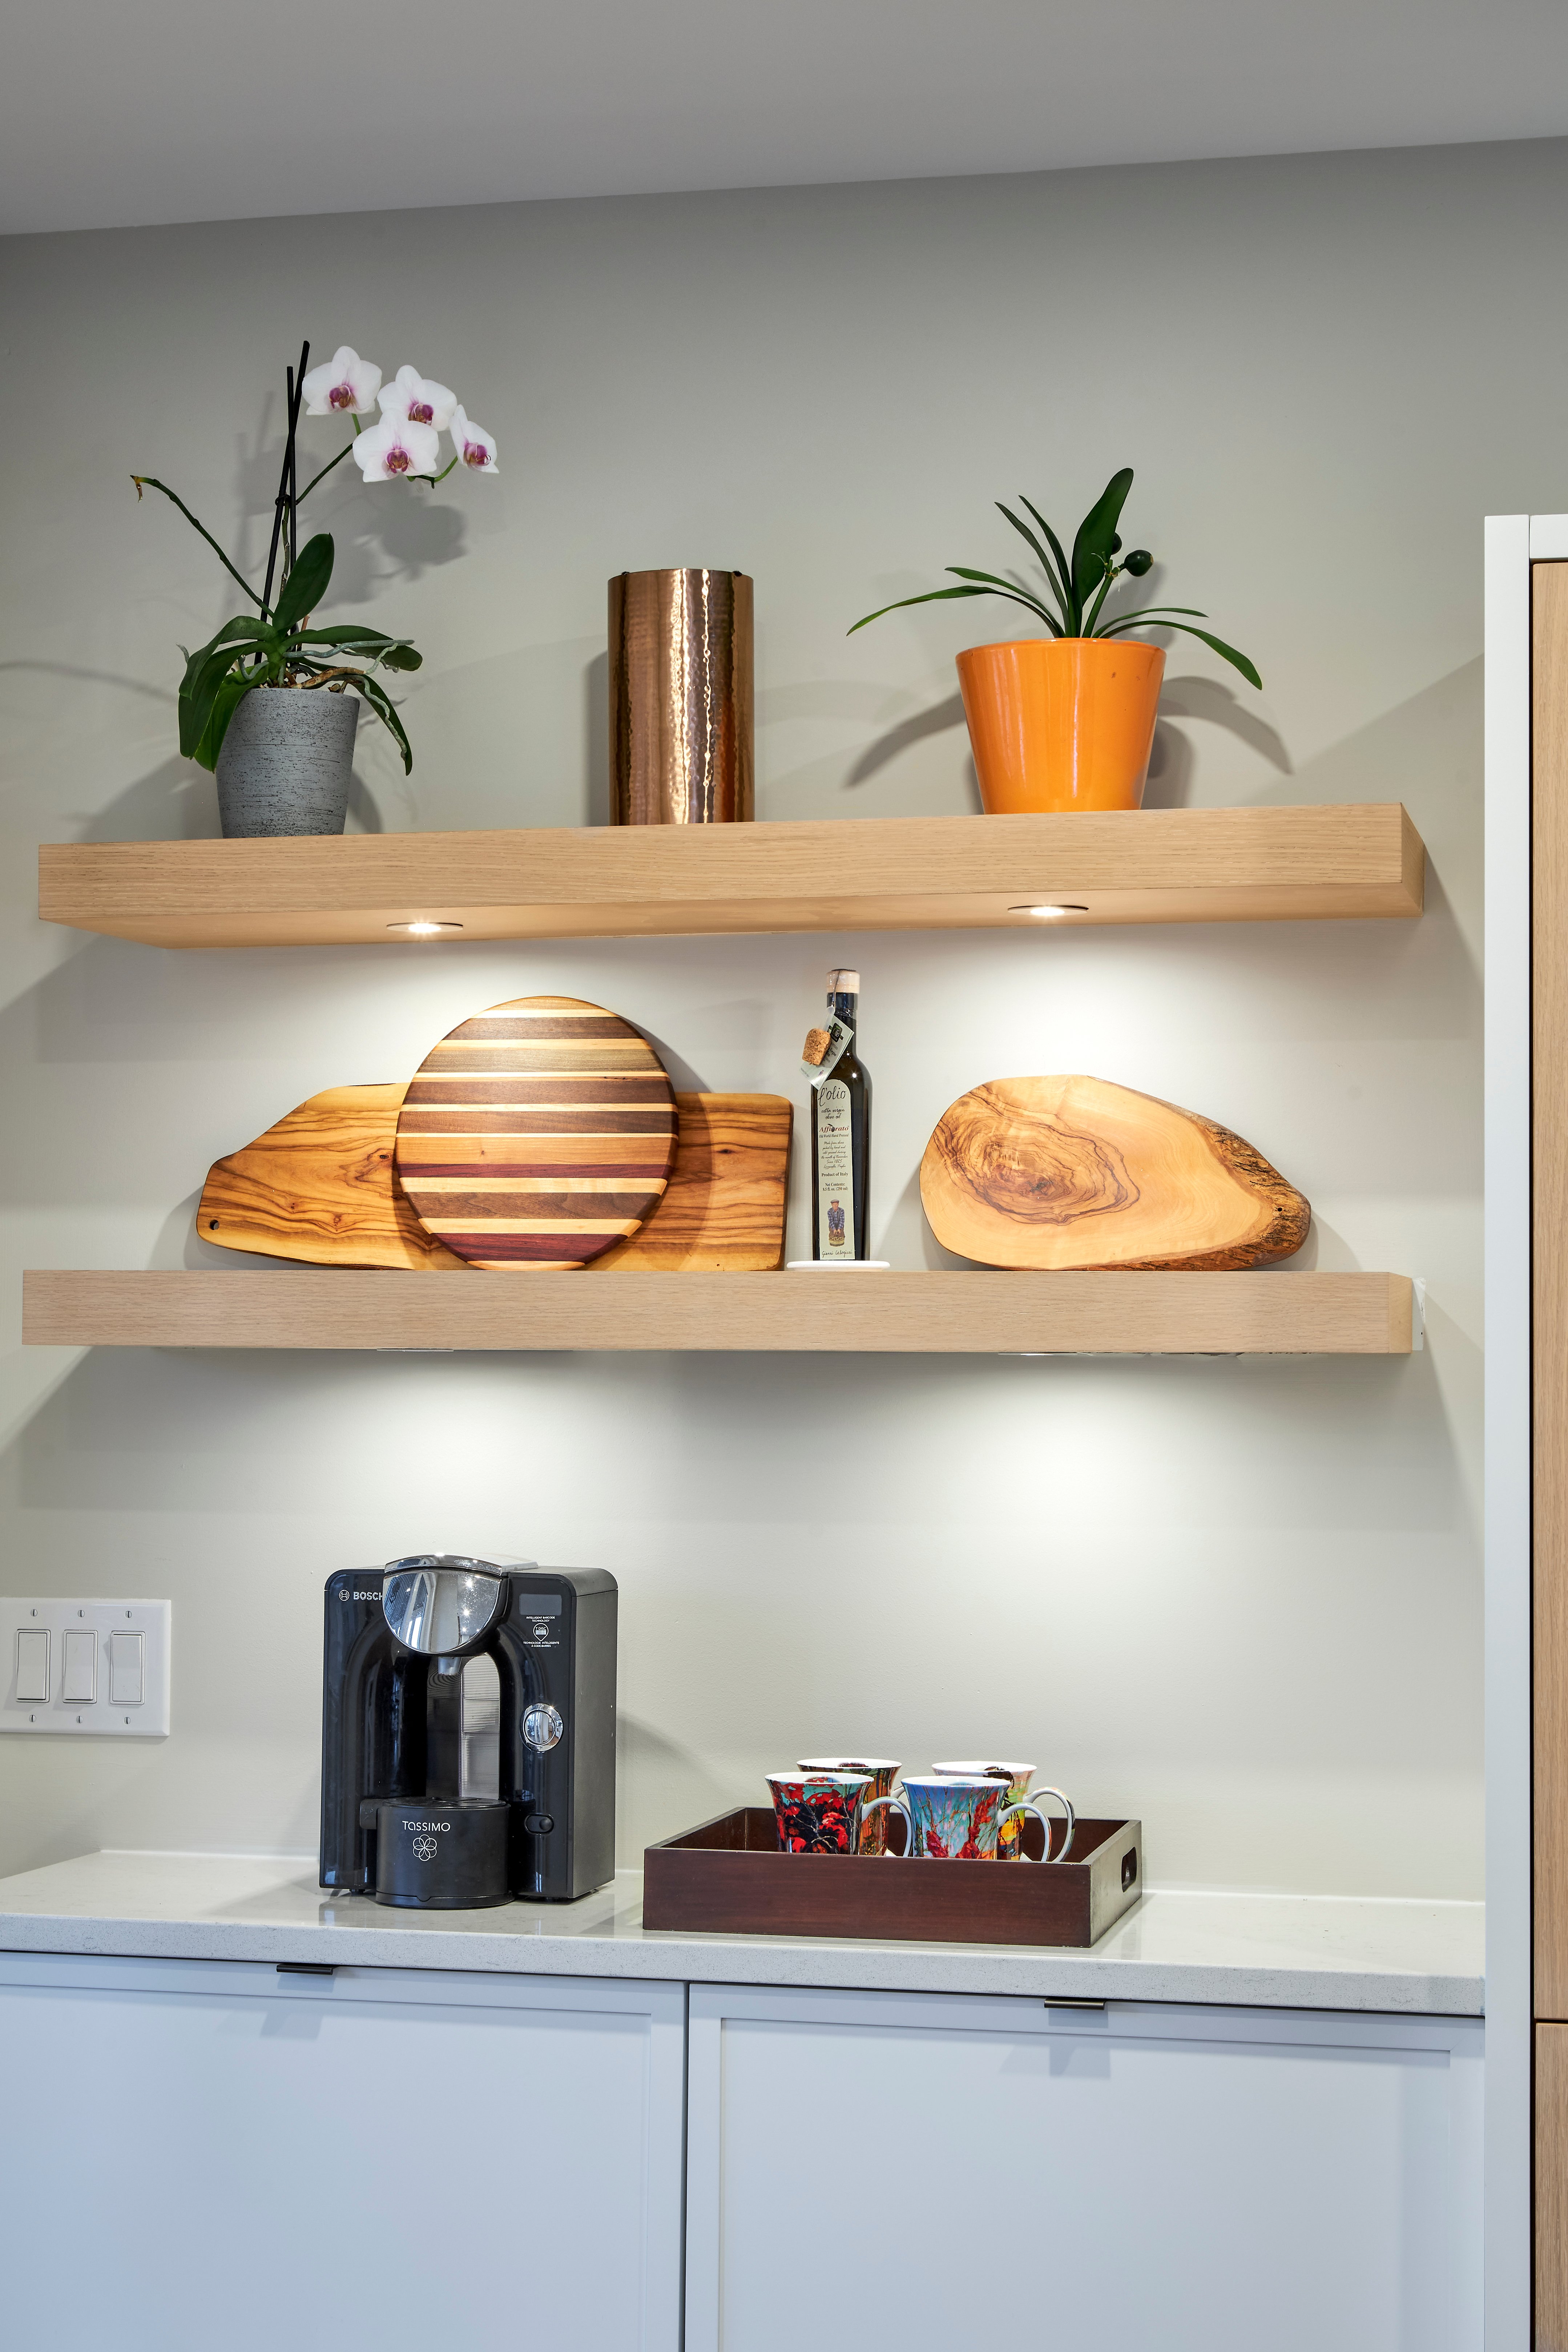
xmin=219 ymin=687 xmax=360 ymax=840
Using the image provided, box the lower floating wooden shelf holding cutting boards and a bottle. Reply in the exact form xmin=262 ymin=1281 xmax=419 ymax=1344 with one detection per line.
xmin=21 ymin=1268 xmax=1413 ymax=1355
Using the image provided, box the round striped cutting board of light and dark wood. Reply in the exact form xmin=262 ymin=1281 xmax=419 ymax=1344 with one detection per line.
xmin=397 ymin=997 xmax=675 ymax=1272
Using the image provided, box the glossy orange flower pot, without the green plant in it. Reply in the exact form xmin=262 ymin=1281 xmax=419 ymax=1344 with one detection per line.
xmin=959 ymin=637 xmax=1166 ymax=816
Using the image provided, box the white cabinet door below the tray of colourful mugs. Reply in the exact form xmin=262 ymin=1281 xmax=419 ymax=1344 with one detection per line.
xmin=686 ymin=1985 xmax=1481 ymax=2352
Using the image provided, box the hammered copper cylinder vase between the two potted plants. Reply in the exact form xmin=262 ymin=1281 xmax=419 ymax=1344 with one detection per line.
xmin=609 ymin=572 xmax=752 ymax=826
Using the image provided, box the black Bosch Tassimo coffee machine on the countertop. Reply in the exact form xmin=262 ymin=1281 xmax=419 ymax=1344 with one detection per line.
xmin=322 ymin=1552 xmax=616 ymax=1910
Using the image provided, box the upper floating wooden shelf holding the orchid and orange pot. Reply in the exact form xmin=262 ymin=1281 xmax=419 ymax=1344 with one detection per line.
xmin=38 ymin=802 xmax=1424 ymax=948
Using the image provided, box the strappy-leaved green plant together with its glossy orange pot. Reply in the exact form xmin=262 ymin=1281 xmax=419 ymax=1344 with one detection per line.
xmin=849 ymin=466 xmax=1262 ymax=816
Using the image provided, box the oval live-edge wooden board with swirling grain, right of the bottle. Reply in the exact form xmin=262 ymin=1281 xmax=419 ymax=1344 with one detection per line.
xmin=919 ymin=1077 xmax=1312 ymax=1272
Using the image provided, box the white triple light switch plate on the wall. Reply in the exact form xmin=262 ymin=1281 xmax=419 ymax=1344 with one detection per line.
xmin=0 ymin=1599 xmax=172 ymax=1740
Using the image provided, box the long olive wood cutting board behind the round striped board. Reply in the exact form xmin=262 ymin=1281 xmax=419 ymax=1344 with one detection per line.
xmin=197 ymin=1082 xmax=792 ymax=1275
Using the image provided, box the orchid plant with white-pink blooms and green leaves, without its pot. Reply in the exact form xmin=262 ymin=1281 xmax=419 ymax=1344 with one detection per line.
xmin=132 ymin=343 xmax=501 ymax=774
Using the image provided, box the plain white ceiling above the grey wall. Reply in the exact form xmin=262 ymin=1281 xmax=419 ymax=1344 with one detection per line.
xmin=0 ymin=0 xmax=1568 ymax=230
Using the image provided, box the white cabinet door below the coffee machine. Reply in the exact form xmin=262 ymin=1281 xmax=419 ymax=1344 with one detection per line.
xmin=0 ymin=1954 xmax=684 ymax=2352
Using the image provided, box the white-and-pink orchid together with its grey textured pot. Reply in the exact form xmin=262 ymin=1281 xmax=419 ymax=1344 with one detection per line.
xmin=132 ymin=343 xmax=498 ymax=837
